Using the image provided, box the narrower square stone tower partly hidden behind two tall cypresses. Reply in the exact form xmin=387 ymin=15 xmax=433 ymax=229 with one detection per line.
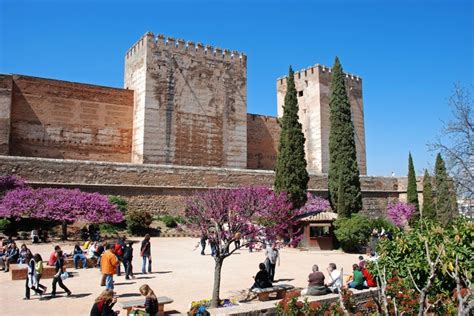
xmin=277 ymin=65 xmax=367 ymax=175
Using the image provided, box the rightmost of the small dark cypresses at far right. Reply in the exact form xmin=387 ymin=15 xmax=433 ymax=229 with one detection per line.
xmin=435 ymin=154 xmax=458 ymax=224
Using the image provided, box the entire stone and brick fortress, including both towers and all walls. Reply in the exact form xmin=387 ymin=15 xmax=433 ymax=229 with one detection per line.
xmin=0 ymin=33 xmax=421 ymax=217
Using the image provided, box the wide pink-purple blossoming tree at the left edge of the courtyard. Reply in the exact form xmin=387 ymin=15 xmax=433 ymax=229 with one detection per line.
xmin=0 ymin=187 xmax=123 ymax=239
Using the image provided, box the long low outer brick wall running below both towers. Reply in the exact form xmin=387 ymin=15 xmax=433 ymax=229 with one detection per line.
xmin=0 ymin=156 xmax=422 ymax=217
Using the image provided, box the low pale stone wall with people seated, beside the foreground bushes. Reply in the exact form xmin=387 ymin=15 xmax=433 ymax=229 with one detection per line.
xmin=208 ymin=289 xmax=377 ymax=316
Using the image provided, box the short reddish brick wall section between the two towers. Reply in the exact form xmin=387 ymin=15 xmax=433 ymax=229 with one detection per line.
xmin=247 ymin=114 xmax=280 ymax=170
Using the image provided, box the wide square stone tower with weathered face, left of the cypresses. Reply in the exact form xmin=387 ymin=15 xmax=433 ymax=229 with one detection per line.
xmin=125 ymin=33 xmax=247 ymax=168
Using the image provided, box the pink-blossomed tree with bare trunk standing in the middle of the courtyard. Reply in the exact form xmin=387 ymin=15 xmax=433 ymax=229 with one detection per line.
xmin=185 ymin=187 xmax=322 ymax=307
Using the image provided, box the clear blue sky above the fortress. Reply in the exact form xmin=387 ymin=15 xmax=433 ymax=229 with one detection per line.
xmin=0 ymin=0 xmax=474 ymax=175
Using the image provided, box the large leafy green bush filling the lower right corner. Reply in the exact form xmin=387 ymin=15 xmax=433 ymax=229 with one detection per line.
xmin=371 ymin=218 xmax=474 ymax=295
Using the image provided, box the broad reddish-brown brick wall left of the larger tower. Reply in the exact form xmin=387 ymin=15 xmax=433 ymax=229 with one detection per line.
xmin=8 ymin=75 xmax=133 ymax=162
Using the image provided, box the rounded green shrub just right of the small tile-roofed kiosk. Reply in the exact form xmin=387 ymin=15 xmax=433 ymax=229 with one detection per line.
xmin=334 ymin=214 xmax=372 ymax=252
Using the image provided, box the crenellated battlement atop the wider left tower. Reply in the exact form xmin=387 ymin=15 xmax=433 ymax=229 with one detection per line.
xmin=126 ymin=32 xmax=247 ymax=63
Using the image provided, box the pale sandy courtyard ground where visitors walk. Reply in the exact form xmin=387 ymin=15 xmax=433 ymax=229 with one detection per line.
xmin=0 ymin=238 xmax=358 ymax=315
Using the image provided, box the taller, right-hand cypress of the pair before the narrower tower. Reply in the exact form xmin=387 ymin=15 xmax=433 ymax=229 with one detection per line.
xmin=328 ymin=57 xmax=362 ymax=216
